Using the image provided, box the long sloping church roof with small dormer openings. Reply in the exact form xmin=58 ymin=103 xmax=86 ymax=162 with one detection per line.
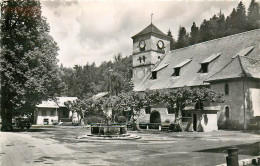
xmin=134 ymin=29 xmax=260 ymax=91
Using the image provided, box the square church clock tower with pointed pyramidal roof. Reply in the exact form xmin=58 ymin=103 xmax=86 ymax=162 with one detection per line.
xmin=132 ymin=23 xmax=171 ymax=87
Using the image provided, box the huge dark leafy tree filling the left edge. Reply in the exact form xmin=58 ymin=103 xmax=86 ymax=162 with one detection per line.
xmin=1 ymin=0 xmax=64 ymax=131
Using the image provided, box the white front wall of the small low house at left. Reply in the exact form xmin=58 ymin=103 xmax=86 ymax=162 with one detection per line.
xmin=36 ymin=108 xmax=58 ymax=125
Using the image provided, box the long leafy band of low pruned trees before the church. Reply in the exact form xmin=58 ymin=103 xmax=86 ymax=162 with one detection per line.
xmin=65 ymin=87 xmax=223 ymax=128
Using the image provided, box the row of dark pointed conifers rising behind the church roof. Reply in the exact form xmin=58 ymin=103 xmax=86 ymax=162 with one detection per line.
xmin=168 ymin=0 xmax=260 ymax=50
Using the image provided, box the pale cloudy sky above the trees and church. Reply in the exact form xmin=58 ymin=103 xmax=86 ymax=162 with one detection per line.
xmin=41 ymin=0 xmax=250 ymax=67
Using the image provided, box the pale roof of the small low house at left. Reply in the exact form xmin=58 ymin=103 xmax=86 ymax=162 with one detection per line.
xmin=36 ymin=97 xmax=78 ymax=108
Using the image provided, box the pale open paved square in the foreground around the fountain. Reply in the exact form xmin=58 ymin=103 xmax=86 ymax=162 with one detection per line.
xmin=0 ymin=127 xmax=260 ymax=166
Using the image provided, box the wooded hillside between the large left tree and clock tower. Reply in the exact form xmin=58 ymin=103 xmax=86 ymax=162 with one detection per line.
xmin=61 ymin=53 xmax=132 ymax=98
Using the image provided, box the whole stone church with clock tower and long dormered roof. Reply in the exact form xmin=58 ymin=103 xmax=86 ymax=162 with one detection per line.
xmin=132 ymin=23 xmax=260 ymax=131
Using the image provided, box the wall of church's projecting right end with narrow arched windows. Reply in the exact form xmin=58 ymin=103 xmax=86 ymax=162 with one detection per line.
xmin=211 ymin=79 xmax=260 ymax=129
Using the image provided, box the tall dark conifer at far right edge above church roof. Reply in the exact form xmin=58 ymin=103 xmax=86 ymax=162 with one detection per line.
xmin=247 ymin=0 xmax=260 ymax=30
